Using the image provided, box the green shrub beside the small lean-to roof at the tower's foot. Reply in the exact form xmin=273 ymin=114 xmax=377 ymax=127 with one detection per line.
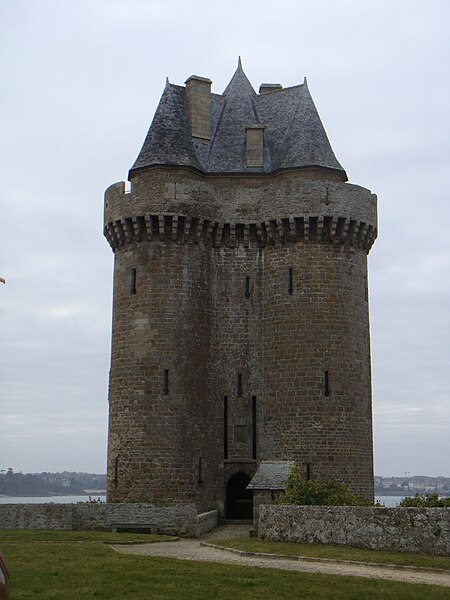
xmin=280 ymin=465 xmax=372 ymax=506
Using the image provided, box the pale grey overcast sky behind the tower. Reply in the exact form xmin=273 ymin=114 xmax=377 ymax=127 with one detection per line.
xmin=0 ymin=0 xmax=450 ymax=476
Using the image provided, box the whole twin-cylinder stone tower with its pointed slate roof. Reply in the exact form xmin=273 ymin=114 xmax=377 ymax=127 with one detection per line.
xmin=105 ymin=61 xmax=377 ymax=517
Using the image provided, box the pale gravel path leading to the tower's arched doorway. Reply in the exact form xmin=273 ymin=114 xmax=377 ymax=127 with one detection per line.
xmin=112 ymin=525 xmax=450 ymax=587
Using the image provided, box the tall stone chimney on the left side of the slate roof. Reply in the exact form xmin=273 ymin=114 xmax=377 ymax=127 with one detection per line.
xmin=185 ymin=75 xmax=212 ymax=140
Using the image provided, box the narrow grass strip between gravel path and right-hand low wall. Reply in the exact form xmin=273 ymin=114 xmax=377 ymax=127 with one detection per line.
xmin=214 ymin=538 xmax=450 ymax=568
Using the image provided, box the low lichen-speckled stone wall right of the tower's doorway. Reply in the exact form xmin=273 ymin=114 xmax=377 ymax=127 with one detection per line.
xmin=258 ymin=505 xmax=450 ymax=556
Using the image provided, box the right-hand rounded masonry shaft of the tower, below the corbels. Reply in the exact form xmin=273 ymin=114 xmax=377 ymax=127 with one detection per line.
xmin=260 ymin=243 xmax=373 ymax=499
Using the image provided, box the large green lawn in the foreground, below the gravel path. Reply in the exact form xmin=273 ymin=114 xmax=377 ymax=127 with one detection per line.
xmin=0 ymin=531 xmax=449 ymax=600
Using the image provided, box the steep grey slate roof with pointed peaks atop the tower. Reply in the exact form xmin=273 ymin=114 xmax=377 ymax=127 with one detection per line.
xmin=130 ymin=60 xmax=347 ymax=179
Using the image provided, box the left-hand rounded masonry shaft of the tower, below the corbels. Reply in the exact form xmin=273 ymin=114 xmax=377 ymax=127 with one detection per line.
xmin=108 ymin=241 xmax=221 ymax=510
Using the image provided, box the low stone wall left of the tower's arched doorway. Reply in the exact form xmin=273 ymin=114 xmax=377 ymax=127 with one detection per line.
xmin=0 ymin=503 xmax=199 ymax=536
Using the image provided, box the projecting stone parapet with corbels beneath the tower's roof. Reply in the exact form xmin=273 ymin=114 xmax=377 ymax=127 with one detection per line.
xmin=104 ymin=170 xmax=377 ymax=252
